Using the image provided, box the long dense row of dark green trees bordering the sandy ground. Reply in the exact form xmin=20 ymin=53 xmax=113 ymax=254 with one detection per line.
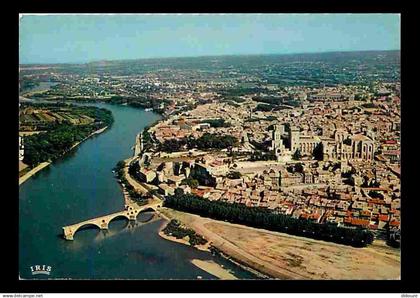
xmin=164 ymin=194 xmax=373 ymax=247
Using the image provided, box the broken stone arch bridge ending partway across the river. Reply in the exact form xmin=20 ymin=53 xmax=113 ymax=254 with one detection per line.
xmin=63 ymin=201 xmax=160 ymax=240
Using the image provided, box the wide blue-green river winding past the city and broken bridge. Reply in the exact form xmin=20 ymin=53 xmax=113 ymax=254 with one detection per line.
xmin=19 ymin=100 xmax=256 ymax=279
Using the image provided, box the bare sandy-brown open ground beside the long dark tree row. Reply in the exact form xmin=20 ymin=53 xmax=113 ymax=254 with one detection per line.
xmin=162 ymin=208 xmax=400 ymax=280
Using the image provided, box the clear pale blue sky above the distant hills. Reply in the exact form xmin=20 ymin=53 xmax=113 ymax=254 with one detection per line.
xmin=19 ymin=14 xmax=400 ymax=64
